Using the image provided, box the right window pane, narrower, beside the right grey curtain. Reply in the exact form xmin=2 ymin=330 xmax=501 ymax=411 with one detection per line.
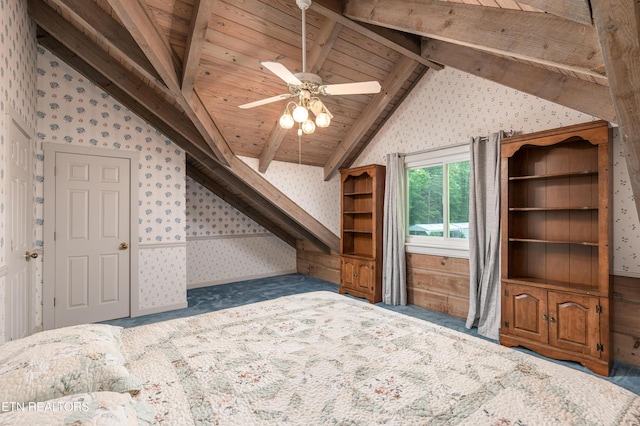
xmin=447 ymin=161 xmax=470 ymax=238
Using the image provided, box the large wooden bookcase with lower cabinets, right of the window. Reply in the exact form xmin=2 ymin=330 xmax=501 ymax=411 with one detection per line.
xmin=500 ymin=121 xmax=611 ymax=376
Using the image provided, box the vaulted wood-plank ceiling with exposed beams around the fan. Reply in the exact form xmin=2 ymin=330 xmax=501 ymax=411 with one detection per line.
xmin=28 ymin=0 xmax=640 ymax=252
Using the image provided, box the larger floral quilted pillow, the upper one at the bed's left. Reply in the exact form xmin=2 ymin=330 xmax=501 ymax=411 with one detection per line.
xmin=0 ymin=324 xmax=142 ymax=408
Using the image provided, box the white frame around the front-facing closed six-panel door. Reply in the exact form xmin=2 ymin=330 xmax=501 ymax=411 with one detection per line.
xmin=42 ymin=143 xmax=140 ymax=330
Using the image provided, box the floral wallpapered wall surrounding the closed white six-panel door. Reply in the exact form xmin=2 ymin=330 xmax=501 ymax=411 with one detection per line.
xmin=35 ymin=47 xmax=186 ymax=318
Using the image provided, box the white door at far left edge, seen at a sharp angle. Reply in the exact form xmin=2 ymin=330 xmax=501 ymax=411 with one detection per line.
xmin=5 ymin=118 xmax=37 ymax=341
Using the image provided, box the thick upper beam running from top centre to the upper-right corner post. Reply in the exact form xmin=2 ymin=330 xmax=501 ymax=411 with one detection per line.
xmin=345 ymin=0 xmax=603 ymax=75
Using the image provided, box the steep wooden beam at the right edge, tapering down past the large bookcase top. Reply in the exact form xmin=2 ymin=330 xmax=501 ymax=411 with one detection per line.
xmin=591 ymin=0 xmax=640 ymax=221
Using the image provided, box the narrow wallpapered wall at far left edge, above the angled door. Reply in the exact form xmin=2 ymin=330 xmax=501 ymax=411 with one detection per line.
xmin=0 ymin=0 xmax=37 ymax=343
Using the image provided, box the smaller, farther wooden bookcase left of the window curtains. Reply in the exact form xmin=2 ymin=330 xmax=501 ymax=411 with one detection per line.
xmin=339 ymin=165 xmax=386 ymax=303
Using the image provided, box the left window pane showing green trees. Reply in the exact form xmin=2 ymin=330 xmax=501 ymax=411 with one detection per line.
xmin=408 ymin=166 xmax=443 ymax=237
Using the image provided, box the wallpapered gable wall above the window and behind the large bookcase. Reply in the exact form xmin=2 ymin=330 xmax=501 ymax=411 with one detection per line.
xmin=354 ymin=67 xmax=640 ymax=277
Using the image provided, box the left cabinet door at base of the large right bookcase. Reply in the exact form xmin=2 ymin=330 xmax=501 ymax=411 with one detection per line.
xmin=502 ymin=284 xmax=549 ymax=343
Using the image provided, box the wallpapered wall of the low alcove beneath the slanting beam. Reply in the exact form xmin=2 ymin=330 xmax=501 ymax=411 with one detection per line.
xmin=185 ymin=177 xmax=296 ymax=287
